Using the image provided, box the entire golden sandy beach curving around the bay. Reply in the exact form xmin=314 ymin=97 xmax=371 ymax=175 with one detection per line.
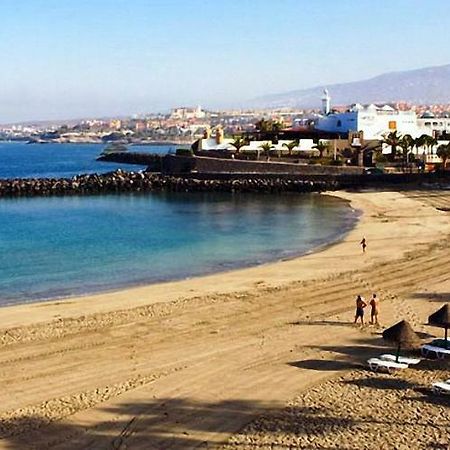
xmin=0 ymin=191 xmax=450 ymax=449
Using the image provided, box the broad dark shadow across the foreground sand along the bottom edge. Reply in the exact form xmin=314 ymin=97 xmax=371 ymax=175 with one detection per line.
xmin=0 ymin=398 xmax=354 ymax=450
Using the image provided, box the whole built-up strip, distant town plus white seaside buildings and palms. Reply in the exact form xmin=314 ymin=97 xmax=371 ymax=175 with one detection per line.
xmin=0 ymin=94 xmax=450 ymax=171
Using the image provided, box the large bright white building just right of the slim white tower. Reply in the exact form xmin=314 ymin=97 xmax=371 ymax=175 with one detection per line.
xmin=315 ymin=103 xmax=422 ymax=139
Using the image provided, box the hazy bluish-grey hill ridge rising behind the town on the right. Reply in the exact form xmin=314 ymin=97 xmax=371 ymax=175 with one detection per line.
xmin=252 ymin=64 xmax=450 ymax=108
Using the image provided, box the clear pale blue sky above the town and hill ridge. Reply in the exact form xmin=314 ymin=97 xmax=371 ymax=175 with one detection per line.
xmin=0 ymin=0 xmax=450 ymax=123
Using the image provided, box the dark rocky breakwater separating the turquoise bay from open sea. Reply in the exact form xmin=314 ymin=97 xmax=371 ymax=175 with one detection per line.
xmin=0 ymin=169 xmax=339 ymax=197
